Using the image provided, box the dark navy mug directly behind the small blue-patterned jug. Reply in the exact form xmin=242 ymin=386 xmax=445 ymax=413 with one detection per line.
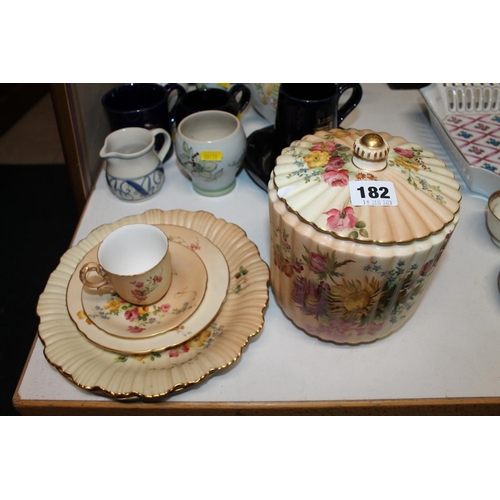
xmin=102 ymin=83 xmax=186 ymax=159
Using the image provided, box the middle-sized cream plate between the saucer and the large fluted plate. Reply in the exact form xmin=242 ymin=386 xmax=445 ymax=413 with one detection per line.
xmin=67 ymin=225 xmax=229 ymax=354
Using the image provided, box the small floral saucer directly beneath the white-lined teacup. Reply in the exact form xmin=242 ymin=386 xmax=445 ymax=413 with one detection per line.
xmin=80 ymin=241 xmax=209 ymax=339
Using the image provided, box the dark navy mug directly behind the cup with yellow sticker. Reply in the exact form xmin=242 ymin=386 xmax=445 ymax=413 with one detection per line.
xmin=175 ymin=83 xmax=251 ymax=125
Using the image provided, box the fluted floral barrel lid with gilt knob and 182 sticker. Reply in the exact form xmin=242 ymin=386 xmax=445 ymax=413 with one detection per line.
xmin=269 ymin=129 xmax=461 ymax=244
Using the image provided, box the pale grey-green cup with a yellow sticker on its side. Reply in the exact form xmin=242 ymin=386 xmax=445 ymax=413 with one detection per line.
xmin=175 ymin=111 xmax=246 ymax=196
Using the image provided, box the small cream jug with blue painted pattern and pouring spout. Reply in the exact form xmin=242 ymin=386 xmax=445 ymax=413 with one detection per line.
xmin=100 ymin=127 xmax=172 ymax=201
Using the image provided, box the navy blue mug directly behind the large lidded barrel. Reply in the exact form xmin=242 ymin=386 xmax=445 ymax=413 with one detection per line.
xmin=275 ymin=83 xmax=363 ymax=155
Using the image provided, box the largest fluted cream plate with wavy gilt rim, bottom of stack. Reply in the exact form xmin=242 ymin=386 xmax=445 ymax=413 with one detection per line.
xmin=37 ymin=210 xmax=269 ymax=399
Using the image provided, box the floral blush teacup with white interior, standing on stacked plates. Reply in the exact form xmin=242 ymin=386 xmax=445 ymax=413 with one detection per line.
xmin=80 ymin=224 xmax=172 ymax=306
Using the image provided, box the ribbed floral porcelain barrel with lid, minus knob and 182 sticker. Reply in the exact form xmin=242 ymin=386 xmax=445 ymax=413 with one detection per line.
xmin=269 ymin=129 xmax=461 ymax=344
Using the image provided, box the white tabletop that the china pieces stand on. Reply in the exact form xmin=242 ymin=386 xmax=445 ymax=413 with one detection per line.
xmin=14 ymin=84 xmax=500 ymax=413
